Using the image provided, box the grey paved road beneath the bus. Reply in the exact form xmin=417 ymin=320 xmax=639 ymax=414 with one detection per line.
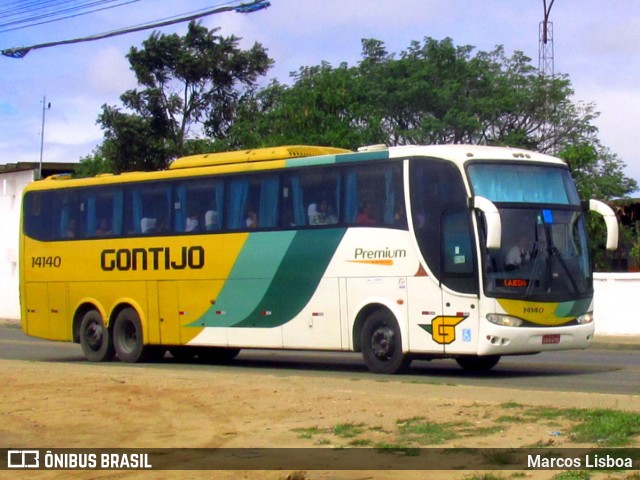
xmin=0 ymin=325 xmax=640 ymax=401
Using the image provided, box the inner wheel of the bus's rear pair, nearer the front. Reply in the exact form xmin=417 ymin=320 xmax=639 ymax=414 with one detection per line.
xmin=113 ymin=307 xmax=159 ymax=363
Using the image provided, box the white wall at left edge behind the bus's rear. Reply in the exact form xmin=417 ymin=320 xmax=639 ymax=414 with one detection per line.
xmin=0 ymin=170 xmax=35 ymax=319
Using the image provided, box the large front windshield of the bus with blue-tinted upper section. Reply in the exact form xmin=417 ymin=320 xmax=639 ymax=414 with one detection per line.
xmin=468 ymin=164 xmax=593 ymax=301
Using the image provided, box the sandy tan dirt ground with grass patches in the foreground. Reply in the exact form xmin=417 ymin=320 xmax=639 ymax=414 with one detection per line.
xmin=0 ymin=344 xmax=640 ymax=480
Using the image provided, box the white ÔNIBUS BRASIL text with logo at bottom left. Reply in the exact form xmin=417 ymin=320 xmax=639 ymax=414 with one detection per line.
xmin=7 ymin=449 xmax=153 ymax=470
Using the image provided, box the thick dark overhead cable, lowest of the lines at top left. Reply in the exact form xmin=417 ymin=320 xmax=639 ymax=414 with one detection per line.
xmin=0 ymin=0 xmax=271 ymax=58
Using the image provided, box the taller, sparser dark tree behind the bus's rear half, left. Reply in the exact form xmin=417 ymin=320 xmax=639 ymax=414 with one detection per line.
xmin=98 ymin=22 xmax=273 ymax=172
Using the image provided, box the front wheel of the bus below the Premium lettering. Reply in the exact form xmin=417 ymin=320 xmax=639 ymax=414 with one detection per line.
xmin=361 ymin=311 xmax=411 ymax=374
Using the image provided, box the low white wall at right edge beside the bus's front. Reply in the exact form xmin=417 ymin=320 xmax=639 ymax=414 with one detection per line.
xmin=593 ymin=273 xmax=640 ymax=335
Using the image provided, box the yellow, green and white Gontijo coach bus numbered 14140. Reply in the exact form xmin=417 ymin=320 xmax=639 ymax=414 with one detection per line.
xmin=20 ymin=145 xmax=617 ymax=373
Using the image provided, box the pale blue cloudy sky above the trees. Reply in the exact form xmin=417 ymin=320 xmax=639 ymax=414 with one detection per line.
xmin=0 ymin=0 xmax=640 ymax=192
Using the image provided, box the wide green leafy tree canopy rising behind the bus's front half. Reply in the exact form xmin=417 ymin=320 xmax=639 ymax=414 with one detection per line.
xmin=225 ymin=38 xmax=608 ymax=153
